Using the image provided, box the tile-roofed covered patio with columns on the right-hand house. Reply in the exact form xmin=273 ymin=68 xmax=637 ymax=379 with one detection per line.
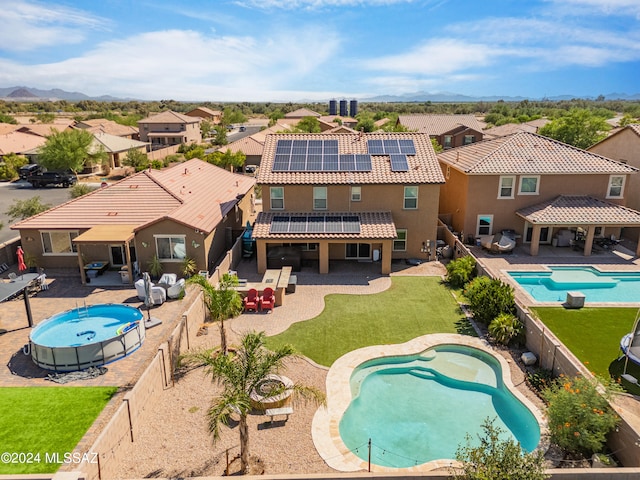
xmin=516 ymin=195 xmax=640 ymax=257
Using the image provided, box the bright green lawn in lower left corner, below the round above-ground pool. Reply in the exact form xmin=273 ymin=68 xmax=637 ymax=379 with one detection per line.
xmin=0 ymin=387 xmax=117 ymax=474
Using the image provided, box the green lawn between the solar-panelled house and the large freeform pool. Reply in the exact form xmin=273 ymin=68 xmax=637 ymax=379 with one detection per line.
xmin=267 ymin=276 xmax=475 ymax=366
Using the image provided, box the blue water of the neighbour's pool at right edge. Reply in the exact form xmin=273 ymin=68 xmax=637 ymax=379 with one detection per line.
xmin=507 ymin=267 xmax=640 ymax=303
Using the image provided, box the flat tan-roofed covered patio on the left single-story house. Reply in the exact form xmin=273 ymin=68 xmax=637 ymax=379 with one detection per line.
xmin=73 ymin=224 xmax=137 ymax=285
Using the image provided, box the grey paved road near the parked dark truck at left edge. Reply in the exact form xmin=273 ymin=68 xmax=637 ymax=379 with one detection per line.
xmin=0 ymin=181 xmax=70 ymax=243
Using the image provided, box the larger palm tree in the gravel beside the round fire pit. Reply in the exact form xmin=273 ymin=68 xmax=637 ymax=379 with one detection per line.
xmin=186 ymin=332 xmax=324 ymax=473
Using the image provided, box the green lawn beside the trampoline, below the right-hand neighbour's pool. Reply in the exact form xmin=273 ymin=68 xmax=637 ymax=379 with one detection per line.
xmin=532 ymin=307 xmax=640 ymax=393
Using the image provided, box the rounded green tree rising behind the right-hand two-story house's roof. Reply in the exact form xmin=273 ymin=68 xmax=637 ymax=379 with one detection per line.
xmin=540 ymin=108 xmax=611 ymax=149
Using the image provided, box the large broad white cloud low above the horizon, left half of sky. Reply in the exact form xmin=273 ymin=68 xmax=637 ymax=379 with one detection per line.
xmin=0 ymin=26 xmax=341 ymax=100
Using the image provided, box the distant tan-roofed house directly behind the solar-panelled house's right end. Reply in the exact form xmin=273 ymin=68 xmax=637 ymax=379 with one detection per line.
xmin=397 ymin=114 xmax=483 ymax=150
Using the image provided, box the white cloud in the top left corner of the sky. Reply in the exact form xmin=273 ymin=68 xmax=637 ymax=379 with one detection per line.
xmin=0 ymin=0 xmax=106 ymax=51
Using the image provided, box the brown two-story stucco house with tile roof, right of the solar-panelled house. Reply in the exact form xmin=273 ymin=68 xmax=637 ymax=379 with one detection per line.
xmin=438 ymin=132 xmax=640 ymax=255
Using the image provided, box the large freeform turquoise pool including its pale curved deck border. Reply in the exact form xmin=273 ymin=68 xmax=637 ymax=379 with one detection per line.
xmin=312 ymin=334 xmax=542 ymax=471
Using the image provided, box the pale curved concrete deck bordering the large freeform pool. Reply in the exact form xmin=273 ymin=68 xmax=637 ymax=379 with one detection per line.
xmin=311 ymin=334 xmax=548 ymax=473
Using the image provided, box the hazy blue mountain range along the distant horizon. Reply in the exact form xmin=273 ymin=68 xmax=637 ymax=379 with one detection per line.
xmin=0 ymin=86 xmax=640 ymax=103
